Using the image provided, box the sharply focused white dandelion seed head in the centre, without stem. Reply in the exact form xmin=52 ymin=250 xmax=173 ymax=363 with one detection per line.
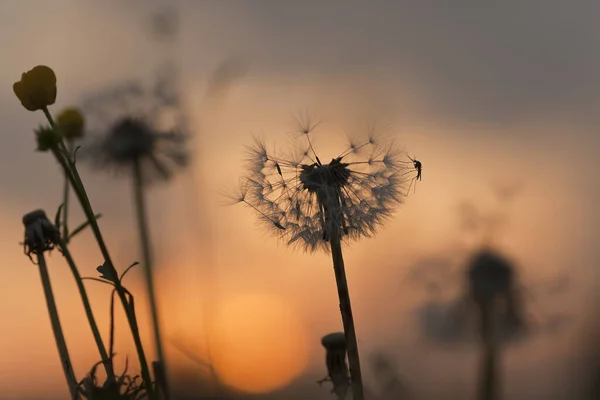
xmin=233 ymin=118 xmax=411 ymax=251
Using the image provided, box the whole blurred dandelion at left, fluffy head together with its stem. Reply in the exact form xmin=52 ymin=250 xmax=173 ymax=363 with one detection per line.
xmin=82 ymin=74 xmax=189 ymax=398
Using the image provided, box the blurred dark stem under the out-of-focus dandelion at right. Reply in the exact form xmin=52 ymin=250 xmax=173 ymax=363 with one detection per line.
xmin=477 ymin=299 xmax=499 ymax=400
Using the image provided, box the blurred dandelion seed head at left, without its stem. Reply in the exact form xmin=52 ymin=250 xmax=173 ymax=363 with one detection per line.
xmin=81 ymin=75 xmax=189 ymax=183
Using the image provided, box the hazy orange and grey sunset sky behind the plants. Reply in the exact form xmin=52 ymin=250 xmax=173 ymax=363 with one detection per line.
xmin=0 ymin=0 xmax=600 ymax=400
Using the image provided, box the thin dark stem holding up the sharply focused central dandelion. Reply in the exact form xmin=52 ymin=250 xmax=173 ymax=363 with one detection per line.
xmin=329 ymin=228 xmax=364 ymax=400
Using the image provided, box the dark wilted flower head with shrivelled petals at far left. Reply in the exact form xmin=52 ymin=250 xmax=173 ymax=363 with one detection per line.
xmin=23 ymin=210 xmax=60 ymax=258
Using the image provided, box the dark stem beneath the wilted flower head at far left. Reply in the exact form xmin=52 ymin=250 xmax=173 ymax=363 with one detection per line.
xmin=37 ymin=253 xmax=79 ymax=399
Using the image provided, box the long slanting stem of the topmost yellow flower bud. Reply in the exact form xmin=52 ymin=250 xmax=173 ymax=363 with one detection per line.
xmin=43 ymin=107 xmax=156 ymax=400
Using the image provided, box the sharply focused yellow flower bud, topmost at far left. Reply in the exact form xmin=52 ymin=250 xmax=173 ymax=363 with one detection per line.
xmin=13 ymin=65 xmax=56 ymax=111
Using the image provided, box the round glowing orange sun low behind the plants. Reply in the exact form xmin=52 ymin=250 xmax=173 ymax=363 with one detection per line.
xmin=213 ymin=294 xmax=308 ymax=393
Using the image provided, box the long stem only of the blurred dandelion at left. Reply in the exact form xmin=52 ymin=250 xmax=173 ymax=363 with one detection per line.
xmin=133 ymin=159 xmax=169 ymax=400
